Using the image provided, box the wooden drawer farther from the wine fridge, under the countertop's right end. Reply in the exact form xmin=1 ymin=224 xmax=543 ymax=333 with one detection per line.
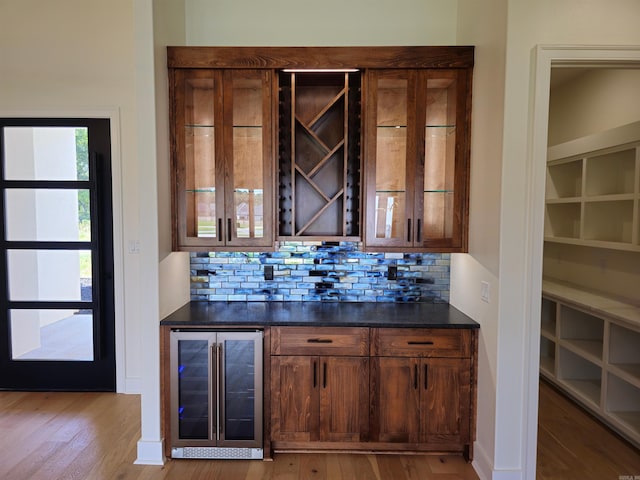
xmin=371 ymin=328 xmax=471 ymax=358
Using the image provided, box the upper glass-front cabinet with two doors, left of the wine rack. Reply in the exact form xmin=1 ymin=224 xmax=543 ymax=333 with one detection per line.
xmin=171 ymin=69 xmax=273 ymax=250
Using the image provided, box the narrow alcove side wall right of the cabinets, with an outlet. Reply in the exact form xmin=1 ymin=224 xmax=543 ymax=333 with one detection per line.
xmin=458 ymin=0 xmax=507 ymax=478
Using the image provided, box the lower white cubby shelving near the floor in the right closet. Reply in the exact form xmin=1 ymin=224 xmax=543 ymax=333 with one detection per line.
xmin=540 ymin=279 xmax=640 ymax=446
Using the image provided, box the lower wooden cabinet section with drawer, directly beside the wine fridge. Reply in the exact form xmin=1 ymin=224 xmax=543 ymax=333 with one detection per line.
xmin=271 ymin=327 xmax=369 ymax=448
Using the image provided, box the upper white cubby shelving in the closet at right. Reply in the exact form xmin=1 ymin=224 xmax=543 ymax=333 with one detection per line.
xmin=545 ymin=122 xmax=640 ymax=252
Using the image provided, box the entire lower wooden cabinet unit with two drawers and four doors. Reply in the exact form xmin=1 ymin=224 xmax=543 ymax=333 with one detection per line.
xmin=270 ymin=327 xmax=477 ymax=460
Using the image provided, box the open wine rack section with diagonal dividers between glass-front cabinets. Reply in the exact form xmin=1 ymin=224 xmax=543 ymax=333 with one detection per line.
xmin=278 ymin=71 xmax=361 ymax=240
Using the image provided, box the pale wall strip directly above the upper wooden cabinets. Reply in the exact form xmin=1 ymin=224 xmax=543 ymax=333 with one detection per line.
xmin=186 ymin=0 xmax=457 ymax=46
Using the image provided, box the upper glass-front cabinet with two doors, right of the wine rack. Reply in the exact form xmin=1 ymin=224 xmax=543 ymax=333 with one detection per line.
xmin=365 ymin=69 xmax=470 ymax=252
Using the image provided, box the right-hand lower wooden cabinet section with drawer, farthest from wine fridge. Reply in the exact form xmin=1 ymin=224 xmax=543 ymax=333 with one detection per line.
xmin=371 ymin=329 xmax=472 ymax=449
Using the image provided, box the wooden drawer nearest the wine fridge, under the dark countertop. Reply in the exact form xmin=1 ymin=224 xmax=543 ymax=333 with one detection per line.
xmin=271 ymin=327 xmax=369 ymax=356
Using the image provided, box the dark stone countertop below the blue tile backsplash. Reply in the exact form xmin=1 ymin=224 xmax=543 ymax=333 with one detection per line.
xmin=160 ymin=301 xmax=480 ymax=328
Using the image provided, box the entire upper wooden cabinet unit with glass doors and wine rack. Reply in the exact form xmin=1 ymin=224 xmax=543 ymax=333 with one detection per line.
xmin=168 ymin=47 xmax=473 ymax=252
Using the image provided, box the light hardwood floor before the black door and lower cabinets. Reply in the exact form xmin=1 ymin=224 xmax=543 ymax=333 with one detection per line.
xmin=0 ymin=392 xmax=478 ymax=480
